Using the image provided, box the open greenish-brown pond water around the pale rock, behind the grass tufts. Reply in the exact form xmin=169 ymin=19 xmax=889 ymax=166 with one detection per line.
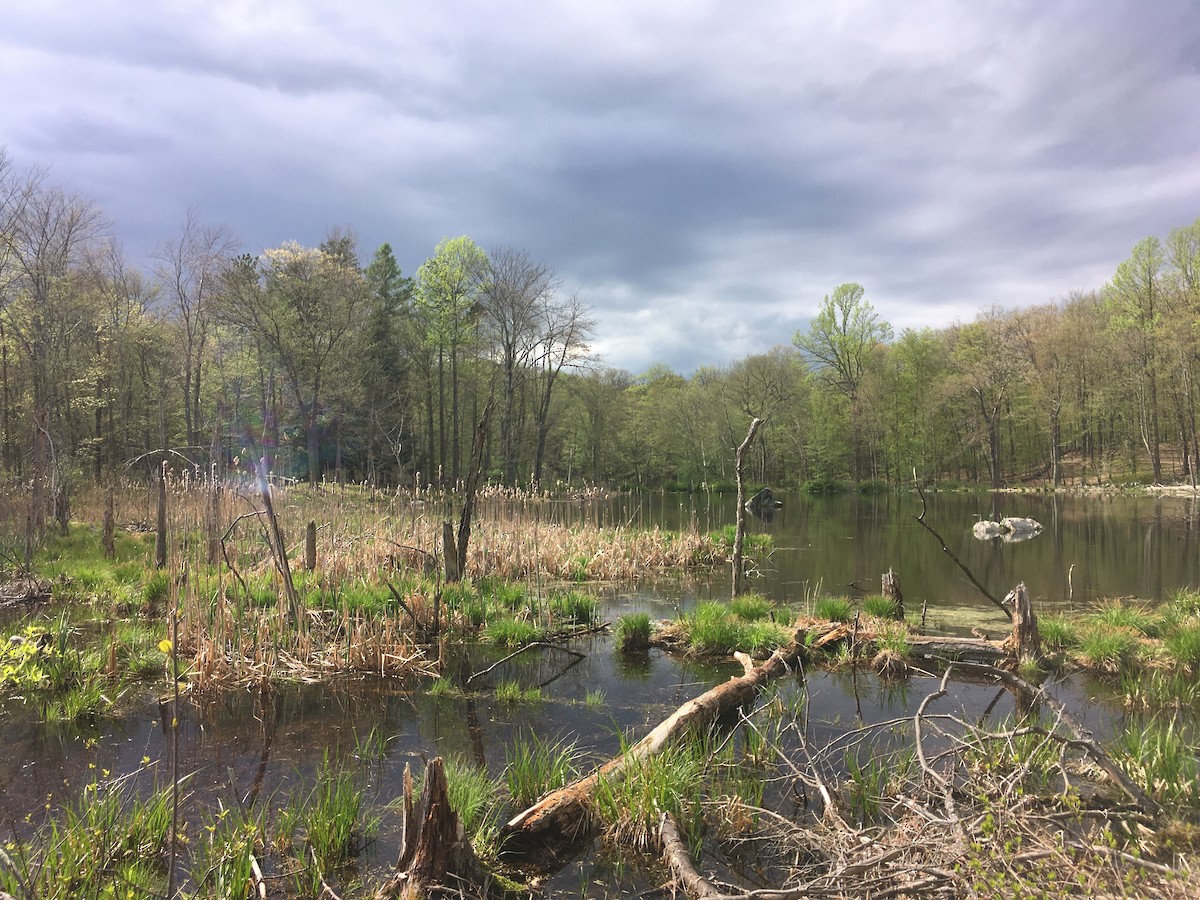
xmin=585 ymin=493 xmax=1200 ymax=630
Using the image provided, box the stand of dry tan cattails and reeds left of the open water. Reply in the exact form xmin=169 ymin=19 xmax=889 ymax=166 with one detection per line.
xmin=74 ymin=476 xmax=724 ymax=690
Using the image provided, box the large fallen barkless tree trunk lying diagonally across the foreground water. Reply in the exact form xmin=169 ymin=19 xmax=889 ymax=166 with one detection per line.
xmin=500 ymin=646 xmax=797 ymax=869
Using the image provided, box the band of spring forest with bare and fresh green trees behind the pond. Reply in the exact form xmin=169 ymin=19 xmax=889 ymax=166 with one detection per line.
xmin=0 ymin=148 xmax=1200 ymax=501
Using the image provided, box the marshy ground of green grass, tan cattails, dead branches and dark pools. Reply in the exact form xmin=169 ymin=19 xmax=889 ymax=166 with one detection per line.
xmin=0 ymin=482 xmax=1200 ymax=898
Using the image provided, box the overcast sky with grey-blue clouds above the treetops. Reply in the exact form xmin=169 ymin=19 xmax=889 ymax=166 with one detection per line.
xmin=0 ymin=0 xmax=1200 ymax=374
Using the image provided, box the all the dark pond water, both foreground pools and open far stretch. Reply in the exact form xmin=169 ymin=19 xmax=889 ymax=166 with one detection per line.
xmin=0 ymin=494 xmax=1200 ymax=896
